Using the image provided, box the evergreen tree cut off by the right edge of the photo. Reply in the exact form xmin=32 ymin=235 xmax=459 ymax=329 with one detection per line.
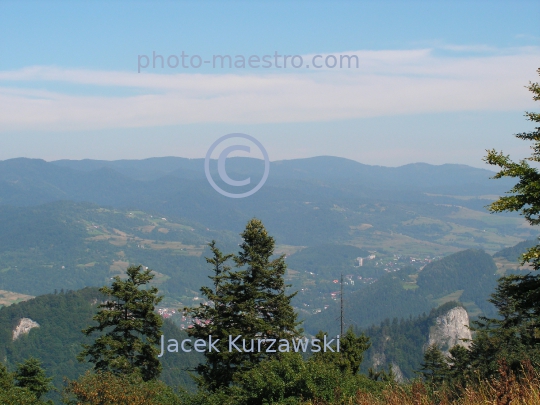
xmin=471 ymin=69 xmax=540 ymax=377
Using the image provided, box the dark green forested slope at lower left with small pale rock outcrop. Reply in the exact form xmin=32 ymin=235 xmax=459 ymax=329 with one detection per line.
xmin=0 ymin=288 xmax=199 ymax=400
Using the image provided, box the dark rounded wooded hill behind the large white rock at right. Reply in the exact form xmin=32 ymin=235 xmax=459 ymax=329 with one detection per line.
xmin=305 ymin=249 xmax=500 ymax=333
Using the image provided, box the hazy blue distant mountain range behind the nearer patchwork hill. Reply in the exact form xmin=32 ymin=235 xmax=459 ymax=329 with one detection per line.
xmin=0 ymin=156 xmax=533 ymax=248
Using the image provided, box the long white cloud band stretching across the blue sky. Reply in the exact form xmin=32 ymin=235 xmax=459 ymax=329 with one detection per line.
xmin=0 ymin=47 xmax=540 ymax=130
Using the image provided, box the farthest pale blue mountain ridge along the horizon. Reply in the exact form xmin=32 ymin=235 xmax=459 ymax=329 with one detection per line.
xmin=48 ymin=156 xmax=504 ymax=194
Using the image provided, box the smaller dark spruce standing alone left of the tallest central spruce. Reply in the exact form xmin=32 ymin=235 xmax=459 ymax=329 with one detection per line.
xmin=79 ymin=266 xmax=163 ymax=381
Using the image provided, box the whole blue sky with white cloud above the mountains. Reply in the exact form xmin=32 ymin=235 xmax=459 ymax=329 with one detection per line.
xmin=0 ymin=0 xmax=540 ymax=167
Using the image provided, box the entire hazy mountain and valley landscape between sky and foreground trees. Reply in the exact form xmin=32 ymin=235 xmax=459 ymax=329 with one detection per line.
xmin=0 ymin=157 xmax=538 ymax=398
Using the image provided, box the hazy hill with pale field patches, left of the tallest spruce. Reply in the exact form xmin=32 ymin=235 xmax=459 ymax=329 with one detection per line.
xmin=0 ymin=202 xmax=234 ymax=299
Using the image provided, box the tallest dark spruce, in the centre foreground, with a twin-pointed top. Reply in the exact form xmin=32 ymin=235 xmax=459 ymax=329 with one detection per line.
xmin=185 ymin=219 xmax=301 ymax=391
